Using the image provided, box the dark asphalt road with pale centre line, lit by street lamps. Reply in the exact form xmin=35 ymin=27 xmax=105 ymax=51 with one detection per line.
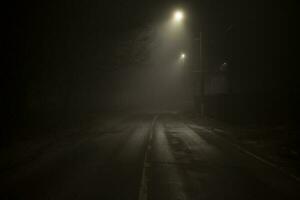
xmin=0 ymin=114 xmax=300 ymax=200
